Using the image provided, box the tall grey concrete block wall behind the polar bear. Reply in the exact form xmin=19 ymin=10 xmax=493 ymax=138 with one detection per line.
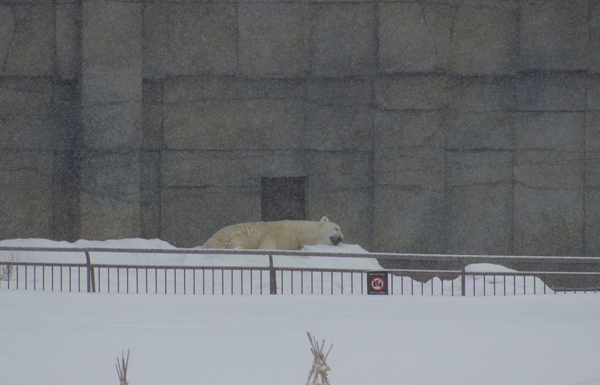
xmin=0 ymin=0 xmax=600 ymax=255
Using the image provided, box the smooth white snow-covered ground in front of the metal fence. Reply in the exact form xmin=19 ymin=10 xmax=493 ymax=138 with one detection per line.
xmin=0 ymin=240 xmax=600 ymax=385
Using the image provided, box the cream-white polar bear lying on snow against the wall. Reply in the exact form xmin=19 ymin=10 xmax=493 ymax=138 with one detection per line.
xmin=204 ymin=217 xmax=344 ymax=250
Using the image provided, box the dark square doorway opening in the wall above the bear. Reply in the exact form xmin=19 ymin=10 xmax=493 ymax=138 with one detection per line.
xmin=261 ymin=177 xmax=307 ymax=222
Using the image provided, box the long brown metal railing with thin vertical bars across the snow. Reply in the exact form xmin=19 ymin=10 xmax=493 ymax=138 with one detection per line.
xmin=0 ymin=247 xmax=600 ymax=296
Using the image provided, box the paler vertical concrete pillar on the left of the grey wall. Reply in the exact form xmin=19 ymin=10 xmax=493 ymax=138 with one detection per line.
xmin=79 ymin=1 xmax=142 ymax=239
